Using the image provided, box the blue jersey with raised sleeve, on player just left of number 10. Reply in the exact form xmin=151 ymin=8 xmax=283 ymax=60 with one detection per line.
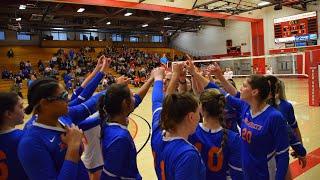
xmin=151 ymin=81 xmax=206 ymax=180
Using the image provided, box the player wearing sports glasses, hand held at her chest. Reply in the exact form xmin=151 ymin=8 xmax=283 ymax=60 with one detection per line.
xmin=18 ymin=81 xmax=89 ymax=180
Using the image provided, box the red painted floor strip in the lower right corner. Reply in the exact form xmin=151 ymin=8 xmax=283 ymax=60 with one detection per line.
xmin=290 ymin=148 xmax=320 ymax=178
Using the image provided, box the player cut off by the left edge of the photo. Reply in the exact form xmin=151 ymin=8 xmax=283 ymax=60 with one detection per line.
xmin=0 ymin=92 xmax=27 ymax=180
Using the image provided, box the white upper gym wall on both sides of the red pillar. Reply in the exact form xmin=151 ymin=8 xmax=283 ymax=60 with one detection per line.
xmin=172 ymin=3 xmax=320 ymax=56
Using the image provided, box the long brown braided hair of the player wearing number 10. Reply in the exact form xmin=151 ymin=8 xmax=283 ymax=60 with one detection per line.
xmin=200 ymin=89 xmax=228 ymax=153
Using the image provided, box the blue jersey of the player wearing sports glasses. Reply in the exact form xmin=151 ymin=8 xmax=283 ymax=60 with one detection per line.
xmin=18 ymin=123 xmax=89 ymax=180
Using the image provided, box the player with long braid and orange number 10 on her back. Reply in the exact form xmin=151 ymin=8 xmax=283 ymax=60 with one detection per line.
xmin=167 ymin=61 xmax=243 ymax=179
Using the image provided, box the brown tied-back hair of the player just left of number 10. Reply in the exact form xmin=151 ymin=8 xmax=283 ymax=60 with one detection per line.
xmin=160 ymin=93 xmax=199 ymax=131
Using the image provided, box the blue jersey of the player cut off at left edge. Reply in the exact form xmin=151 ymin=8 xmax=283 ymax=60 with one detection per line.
xmin=0 ymin=129 xmax=28 ymax=180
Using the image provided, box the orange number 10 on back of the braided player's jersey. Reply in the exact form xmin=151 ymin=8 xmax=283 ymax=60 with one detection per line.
xmin=194 ymin=143 xmax=223 ymax=172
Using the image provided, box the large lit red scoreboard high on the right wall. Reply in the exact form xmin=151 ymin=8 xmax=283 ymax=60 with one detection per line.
xmin=273 ymin=12 xmax=318 ymax=46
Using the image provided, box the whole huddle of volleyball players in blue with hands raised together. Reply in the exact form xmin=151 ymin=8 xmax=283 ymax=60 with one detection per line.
xmin=0 ymin=56 xmax=306 ymax=180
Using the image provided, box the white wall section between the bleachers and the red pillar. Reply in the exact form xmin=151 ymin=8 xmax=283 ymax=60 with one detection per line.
xmin=172 ymin=20 xmax=251 ymax=56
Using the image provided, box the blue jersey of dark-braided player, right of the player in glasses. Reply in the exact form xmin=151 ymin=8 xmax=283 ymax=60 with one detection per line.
xmin=101 ymin=123 xmax=142 ymax=179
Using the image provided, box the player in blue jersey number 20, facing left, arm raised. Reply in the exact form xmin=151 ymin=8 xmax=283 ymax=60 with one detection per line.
xmin=188 ymin=59 xmax=289 ymax=179
